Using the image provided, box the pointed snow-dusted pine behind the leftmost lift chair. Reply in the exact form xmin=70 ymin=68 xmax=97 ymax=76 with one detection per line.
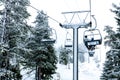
xmin=25 ymin=11 xmax=57 ymax=80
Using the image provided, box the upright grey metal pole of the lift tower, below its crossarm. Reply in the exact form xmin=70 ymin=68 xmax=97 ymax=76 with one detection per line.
xmin=73 ymin=27 xmax=78 ymax=80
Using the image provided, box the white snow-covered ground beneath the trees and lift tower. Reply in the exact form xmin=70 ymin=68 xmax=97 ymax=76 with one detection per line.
xmin=22 ymin=57 xmax=102 ymax=80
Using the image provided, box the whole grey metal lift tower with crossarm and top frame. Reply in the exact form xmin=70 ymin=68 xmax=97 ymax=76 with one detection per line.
xmin=60 ymin=10 xmax=91 ymax=80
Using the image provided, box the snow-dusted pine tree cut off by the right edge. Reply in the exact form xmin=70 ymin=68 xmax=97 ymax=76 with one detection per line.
xmin=101 ymin=4 xmax=120 ymax=80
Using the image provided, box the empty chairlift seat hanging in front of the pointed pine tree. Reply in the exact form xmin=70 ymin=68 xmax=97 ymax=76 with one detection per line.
xmin=41 ymin=28 xmax=57 ymax=44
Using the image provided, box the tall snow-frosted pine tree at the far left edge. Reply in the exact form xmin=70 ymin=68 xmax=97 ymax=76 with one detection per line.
xmin=0 ymin=0 xmax=30 ymax=80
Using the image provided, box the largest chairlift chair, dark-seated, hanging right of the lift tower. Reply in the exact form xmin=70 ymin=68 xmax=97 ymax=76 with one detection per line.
xmin=83 ymin=29 xmax=102 ymax=57
